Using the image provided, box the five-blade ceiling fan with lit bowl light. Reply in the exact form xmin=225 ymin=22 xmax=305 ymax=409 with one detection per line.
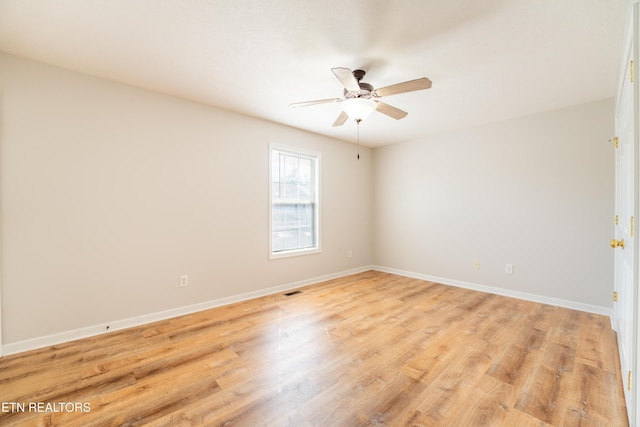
xmin=289 ymin=67 xmax=431 ymax=126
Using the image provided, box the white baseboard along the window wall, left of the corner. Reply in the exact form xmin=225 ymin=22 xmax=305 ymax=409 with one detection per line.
xmin=0 ymin=266 xmax=373 ymax=356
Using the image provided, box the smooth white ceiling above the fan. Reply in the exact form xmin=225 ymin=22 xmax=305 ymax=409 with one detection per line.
xmin=0 ymin=0 xmax=628 ymax=146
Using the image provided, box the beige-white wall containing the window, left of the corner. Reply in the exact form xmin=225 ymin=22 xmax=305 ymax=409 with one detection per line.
xmin=0 ymin=54 xmax=372 ymax=345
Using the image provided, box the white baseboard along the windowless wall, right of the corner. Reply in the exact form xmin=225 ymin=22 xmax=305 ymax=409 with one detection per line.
xmin=371 ymin=265 xmax=611 ymax=318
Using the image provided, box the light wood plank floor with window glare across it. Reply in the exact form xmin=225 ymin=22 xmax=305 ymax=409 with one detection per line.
xmin=0 ymin=271 xmax=627 ymax=427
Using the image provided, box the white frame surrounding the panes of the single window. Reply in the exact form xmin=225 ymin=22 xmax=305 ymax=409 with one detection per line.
xmin=268 ymin=143 xmax=322 ymax=259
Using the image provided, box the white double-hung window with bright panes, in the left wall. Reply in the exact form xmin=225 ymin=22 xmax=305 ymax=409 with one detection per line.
xmin=270 ymin=146 xmax=320 ymax=258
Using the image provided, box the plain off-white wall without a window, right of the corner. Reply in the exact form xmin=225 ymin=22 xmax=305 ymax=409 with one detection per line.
xmin=374 ymin=100 xmax=614 ymax=310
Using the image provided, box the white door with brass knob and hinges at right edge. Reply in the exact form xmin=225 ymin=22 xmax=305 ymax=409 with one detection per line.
xmin=611 ymin=4 xmax=638 ymax=426
